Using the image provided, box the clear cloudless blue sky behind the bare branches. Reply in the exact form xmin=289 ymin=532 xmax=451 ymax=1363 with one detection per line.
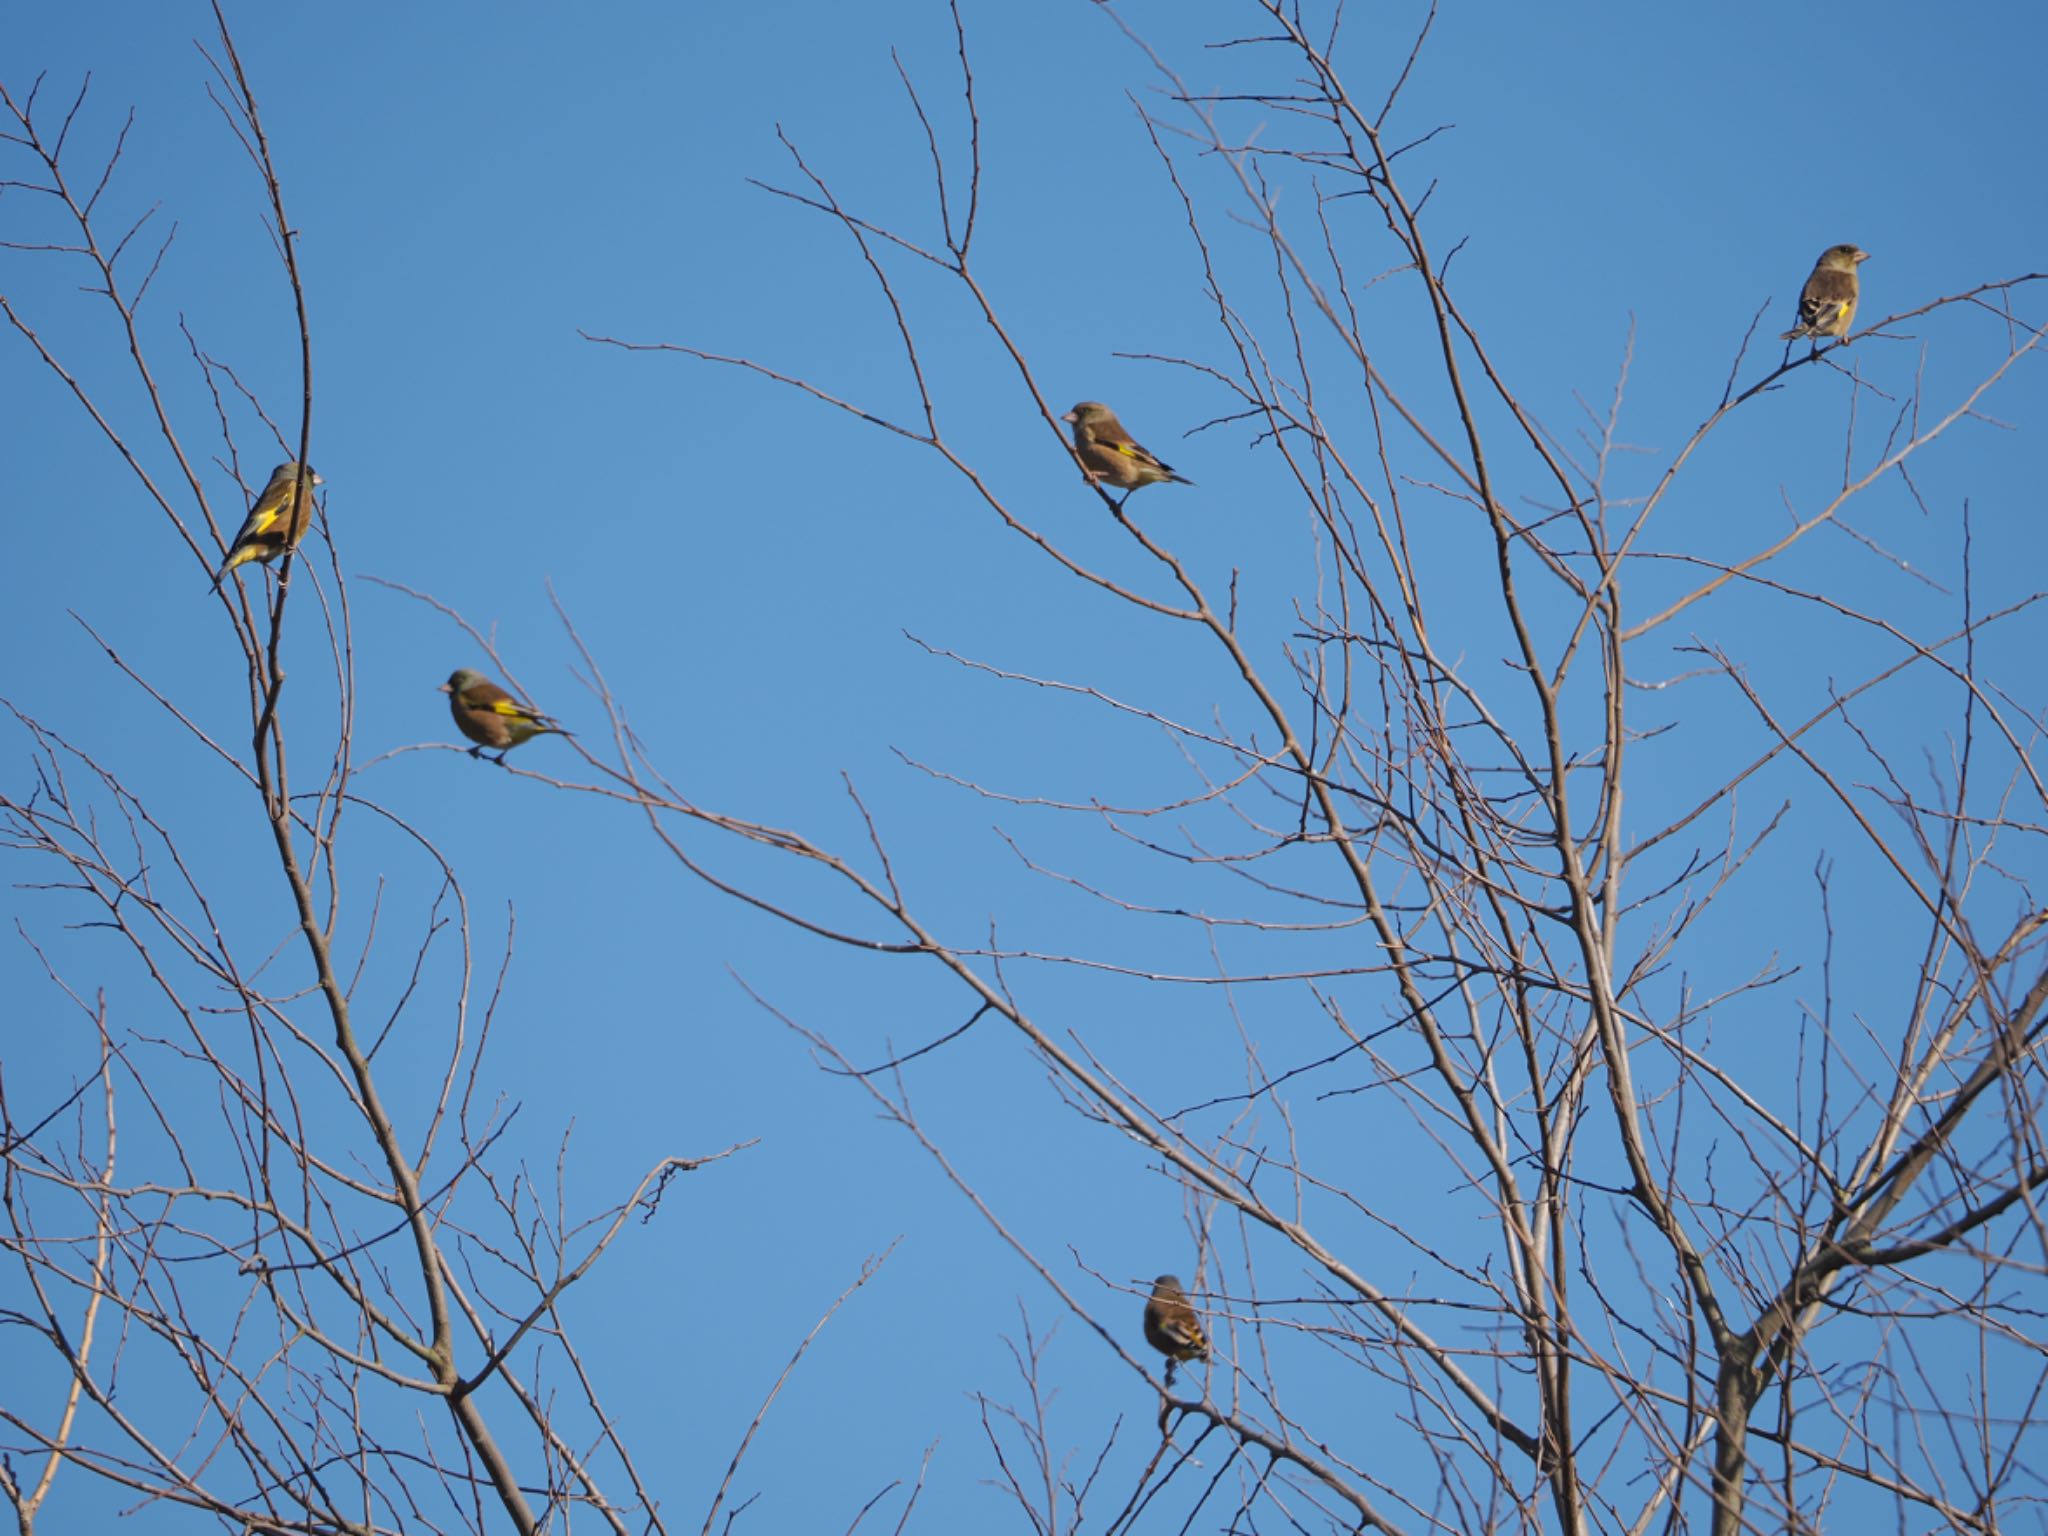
xmin=0 ymin=0 xmax=2048 ymax=1530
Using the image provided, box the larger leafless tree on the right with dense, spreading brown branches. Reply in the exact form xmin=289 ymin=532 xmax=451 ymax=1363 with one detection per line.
xmin=569 ymin=0 xmax=2048 ymax=1536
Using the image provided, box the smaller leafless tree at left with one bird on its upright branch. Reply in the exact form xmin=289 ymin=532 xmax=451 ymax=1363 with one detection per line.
xmin=0 ymin=10 xmax=839 ymax=1536
